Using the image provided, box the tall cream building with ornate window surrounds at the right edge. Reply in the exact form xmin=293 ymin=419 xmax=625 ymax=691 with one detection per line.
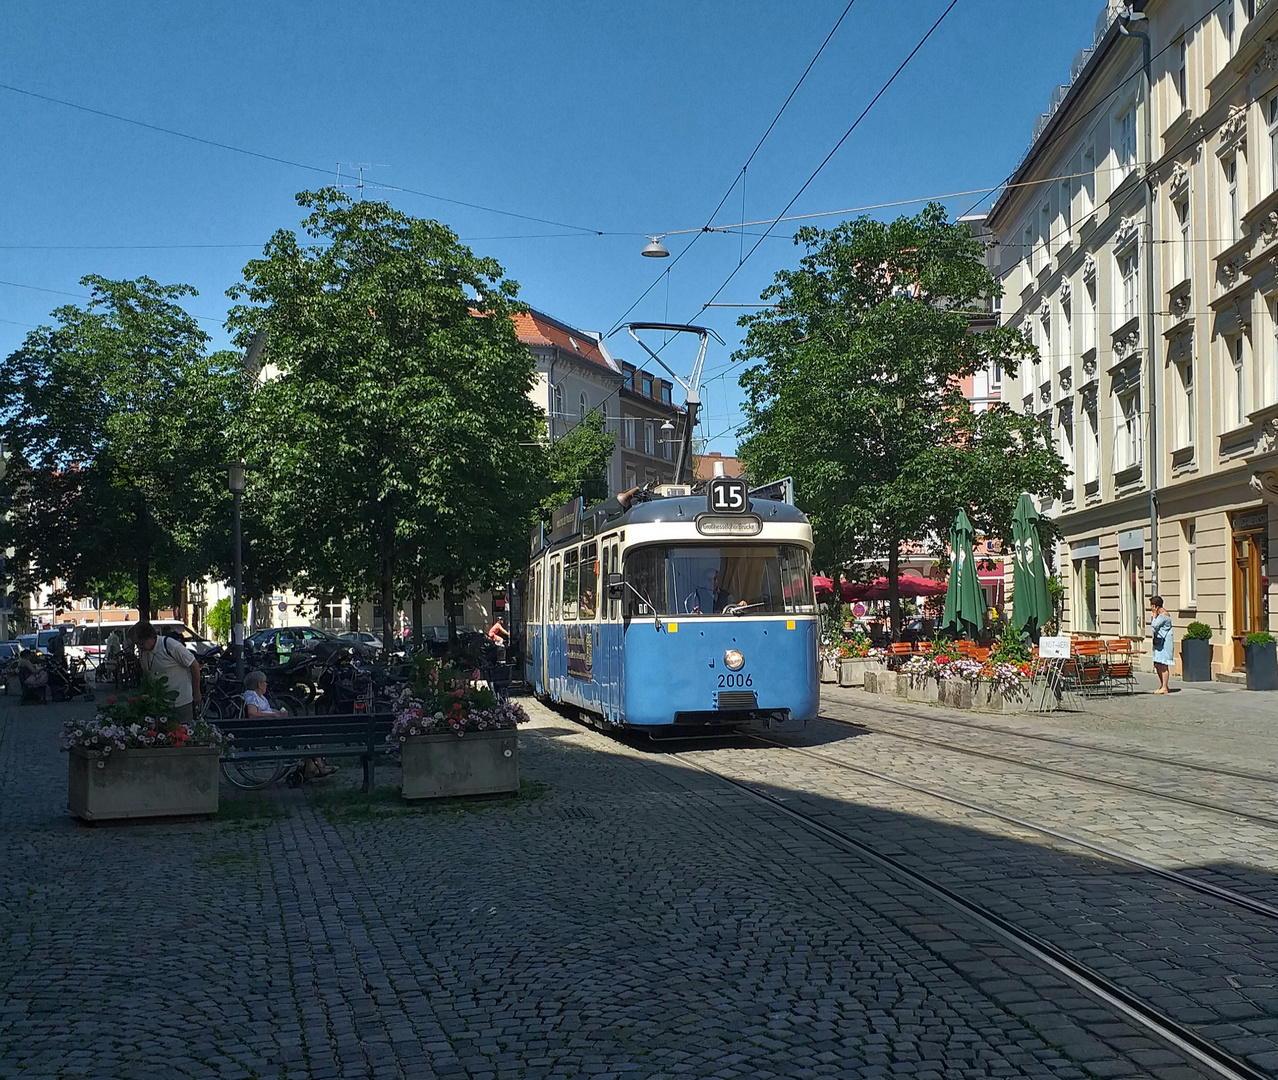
xmin=987 ymin=0 xmax=1278 ymax=672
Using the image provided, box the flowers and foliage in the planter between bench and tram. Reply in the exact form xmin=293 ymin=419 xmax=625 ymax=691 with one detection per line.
xmin=386 ymin=654 xmax=528 ymax=743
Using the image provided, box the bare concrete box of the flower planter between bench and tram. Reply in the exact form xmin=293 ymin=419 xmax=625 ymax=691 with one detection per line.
xmin=400 ymin=727 xmax=519 ymax=799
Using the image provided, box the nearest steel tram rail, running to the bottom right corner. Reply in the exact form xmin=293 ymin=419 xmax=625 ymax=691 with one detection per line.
xmin=670 ymin=736 xmax=1278 ymax=1080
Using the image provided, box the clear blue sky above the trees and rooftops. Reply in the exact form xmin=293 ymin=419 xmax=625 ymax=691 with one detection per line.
xmin=0 ymin=0 xmax=1102 ymax=451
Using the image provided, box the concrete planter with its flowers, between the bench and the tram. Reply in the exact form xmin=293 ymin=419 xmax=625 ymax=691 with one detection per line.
xmin=386 ymin=654 xmax=528 ymax=799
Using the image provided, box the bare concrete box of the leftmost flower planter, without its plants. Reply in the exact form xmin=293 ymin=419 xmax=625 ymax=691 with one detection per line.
xmin=66 ymin=746 xmax=220 ymax=822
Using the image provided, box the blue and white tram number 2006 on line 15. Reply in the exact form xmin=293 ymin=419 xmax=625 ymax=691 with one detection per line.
xmin=524 ymin=484 xmax=820 ymax=734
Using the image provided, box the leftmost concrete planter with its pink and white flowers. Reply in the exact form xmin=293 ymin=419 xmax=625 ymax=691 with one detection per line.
xmin=63 ymin=675 xmax=227 ymax=822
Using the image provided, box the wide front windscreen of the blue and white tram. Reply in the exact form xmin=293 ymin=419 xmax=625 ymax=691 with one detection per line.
xmin=625 ymin=543 xmax=817 ymax=616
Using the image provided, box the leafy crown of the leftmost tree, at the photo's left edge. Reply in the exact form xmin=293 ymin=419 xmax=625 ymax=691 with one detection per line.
xmin=0 ymin=275 xmax=243 ymax=613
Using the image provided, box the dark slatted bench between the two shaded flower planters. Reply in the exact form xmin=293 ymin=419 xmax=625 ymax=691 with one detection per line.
xmin=217 ymin=712 xmax=396 ymax=794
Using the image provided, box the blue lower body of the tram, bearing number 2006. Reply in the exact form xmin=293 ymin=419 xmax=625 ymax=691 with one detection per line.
xmin=525 ymin=616 xmax=820 ymax=729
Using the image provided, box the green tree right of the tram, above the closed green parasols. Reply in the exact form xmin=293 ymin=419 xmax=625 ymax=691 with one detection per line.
xmin=736 ymin=203 xmax=1065 ymax=629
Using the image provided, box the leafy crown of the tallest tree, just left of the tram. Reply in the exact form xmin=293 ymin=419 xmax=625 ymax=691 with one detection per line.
xmin=229 ymin=189 xmax=544 ymax=636
